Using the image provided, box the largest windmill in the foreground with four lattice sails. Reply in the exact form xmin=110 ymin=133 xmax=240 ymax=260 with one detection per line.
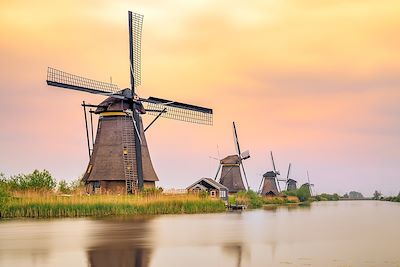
xmin=47 ymin=11 xmax=213 ymax=193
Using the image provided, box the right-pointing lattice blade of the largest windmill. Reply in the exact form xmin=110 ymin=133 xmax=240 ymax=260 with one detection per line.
xmin=143 ymin=97 xmax=213 ymax=125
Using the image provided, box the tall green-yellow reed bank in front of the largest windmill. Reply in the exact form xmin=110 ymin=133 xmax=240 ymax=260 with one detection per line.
xmin=0 ymin=195 xmax=225 ymax=218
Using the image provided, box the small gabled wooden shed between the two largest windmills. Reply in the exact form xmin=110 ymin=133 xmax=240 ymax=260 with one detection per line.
xmin=186 ymin=178 xmax=229 ymax=200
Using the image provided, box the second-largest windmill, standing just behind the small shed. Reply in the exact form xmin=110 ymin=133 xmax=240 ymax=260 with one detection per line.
xmin=215 ymin=122 xmax=250 ymax=193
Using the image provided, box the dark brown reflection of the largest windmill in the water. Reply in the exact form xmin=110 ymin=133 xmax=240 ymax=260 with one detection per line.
xmin=87 ymin=219 xmax=152 ymax=267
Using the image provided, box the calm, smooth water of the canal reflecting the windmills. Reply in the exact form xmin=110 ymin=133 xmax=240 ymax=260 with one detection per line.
xmin=0 ymin=201 xmax=400 ymax=267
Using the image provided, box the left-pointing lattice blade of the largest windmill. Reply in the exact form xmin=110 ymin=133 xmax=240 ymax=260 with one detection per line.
xmin=46 ymin=67 xmax=121 ymax=95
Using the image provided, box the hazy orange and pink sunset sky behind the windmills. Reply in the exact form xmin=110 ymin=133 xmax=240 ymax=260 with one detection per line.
xmin=0 ymin=0 xmax=400 ymax=197
